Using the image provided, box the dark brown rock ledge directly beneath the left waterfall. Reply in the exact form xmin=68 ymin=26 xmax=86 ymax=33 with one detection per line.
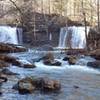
xmin=0 ymin=43 xmax=27 ymax=53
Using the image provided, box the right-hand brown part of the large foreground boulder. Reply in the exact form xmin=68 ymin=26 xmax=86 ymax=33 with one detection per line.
xmin=31 ymin=78 xmax=61 ymax=92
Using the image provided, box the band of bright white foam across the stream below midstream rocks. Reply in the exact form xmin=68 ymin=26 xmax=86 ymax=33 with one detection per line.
xmin=35 ymin=60 xmax=100 ymax=74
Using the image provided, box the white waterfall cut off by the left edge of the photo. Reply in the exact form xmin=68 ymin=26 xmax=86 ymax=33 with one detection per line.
xmin=0 ymin=26 xmax=22 ymax=44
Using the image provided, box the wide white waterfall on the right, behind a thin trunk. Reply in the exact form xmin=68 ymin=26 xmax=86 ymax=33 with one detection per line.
xmin=58 ymin=26 xmax=90 ymax=49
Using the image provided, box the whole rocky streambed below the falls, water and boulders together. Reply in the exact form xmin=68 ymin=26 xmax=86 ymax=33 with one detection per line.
xmin=0 ymin=44 xmax=100 ymax=100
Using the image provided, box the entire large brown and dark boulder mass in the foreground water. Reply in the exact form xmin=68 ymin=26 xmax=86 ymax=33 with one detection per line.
xmin=13 ymin=78 xmax=61 ymax=94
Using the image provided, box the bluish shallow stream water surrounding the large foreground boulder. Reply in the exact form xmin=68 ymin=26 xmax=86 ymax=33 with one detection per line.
xmin=0 ymin=54 xmax=100 ymax=100
